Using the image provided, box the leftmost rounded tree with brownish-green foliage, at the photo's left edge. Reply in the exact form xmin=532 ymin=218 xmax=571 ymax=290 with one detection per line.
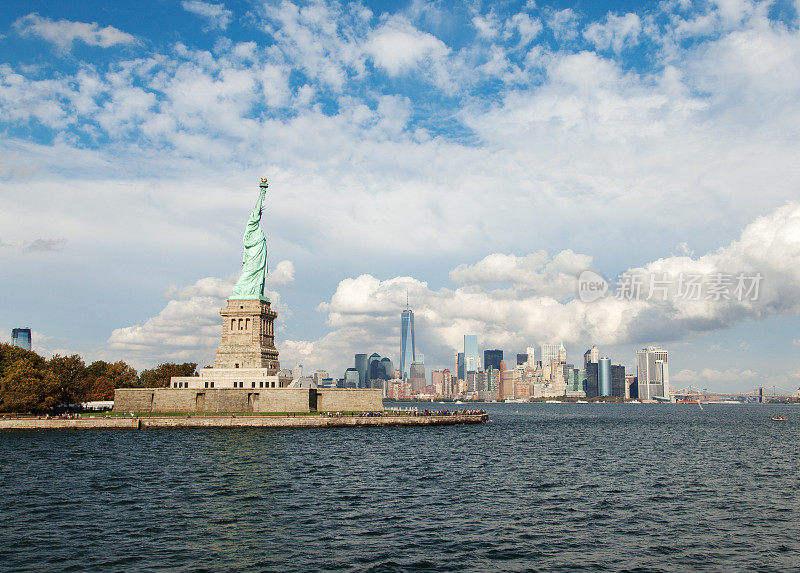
xmin=0 ymin=356 xmax=60 ymax=412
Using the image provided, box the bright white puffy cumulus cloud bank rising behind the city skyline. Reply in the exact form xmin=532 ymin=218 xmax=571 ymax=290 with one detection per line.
xmin=276 ymin=203 xmax=800 ymax=380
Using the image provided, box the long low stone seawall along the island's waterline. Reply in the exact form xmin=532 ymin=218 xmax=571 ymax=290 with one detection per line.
xmin=0 ymin=414 xmax=489 ymax=430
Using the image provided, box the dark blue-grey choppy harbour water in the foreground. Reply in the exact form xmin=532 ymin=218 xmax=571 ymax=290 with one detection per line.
xmin=0 ymin=404 xmax=800 ymax=571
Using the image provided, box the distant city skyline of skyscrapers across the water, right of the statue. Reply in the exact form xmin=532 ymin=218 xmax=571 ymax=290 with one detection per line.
xmin=346 ymin=312 xmax=660 ymax=402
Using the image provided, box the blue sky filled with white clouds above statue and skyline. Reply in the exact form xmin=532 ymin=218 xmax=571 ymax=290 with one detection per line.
xmin=0 ymin=0 xmax=800 ymax=389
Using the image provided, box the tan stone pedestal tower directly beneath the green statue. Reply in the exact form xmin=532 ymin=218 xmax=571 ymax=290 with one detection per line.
xmin=214 ymin=299 xmax=281 ymax=376
